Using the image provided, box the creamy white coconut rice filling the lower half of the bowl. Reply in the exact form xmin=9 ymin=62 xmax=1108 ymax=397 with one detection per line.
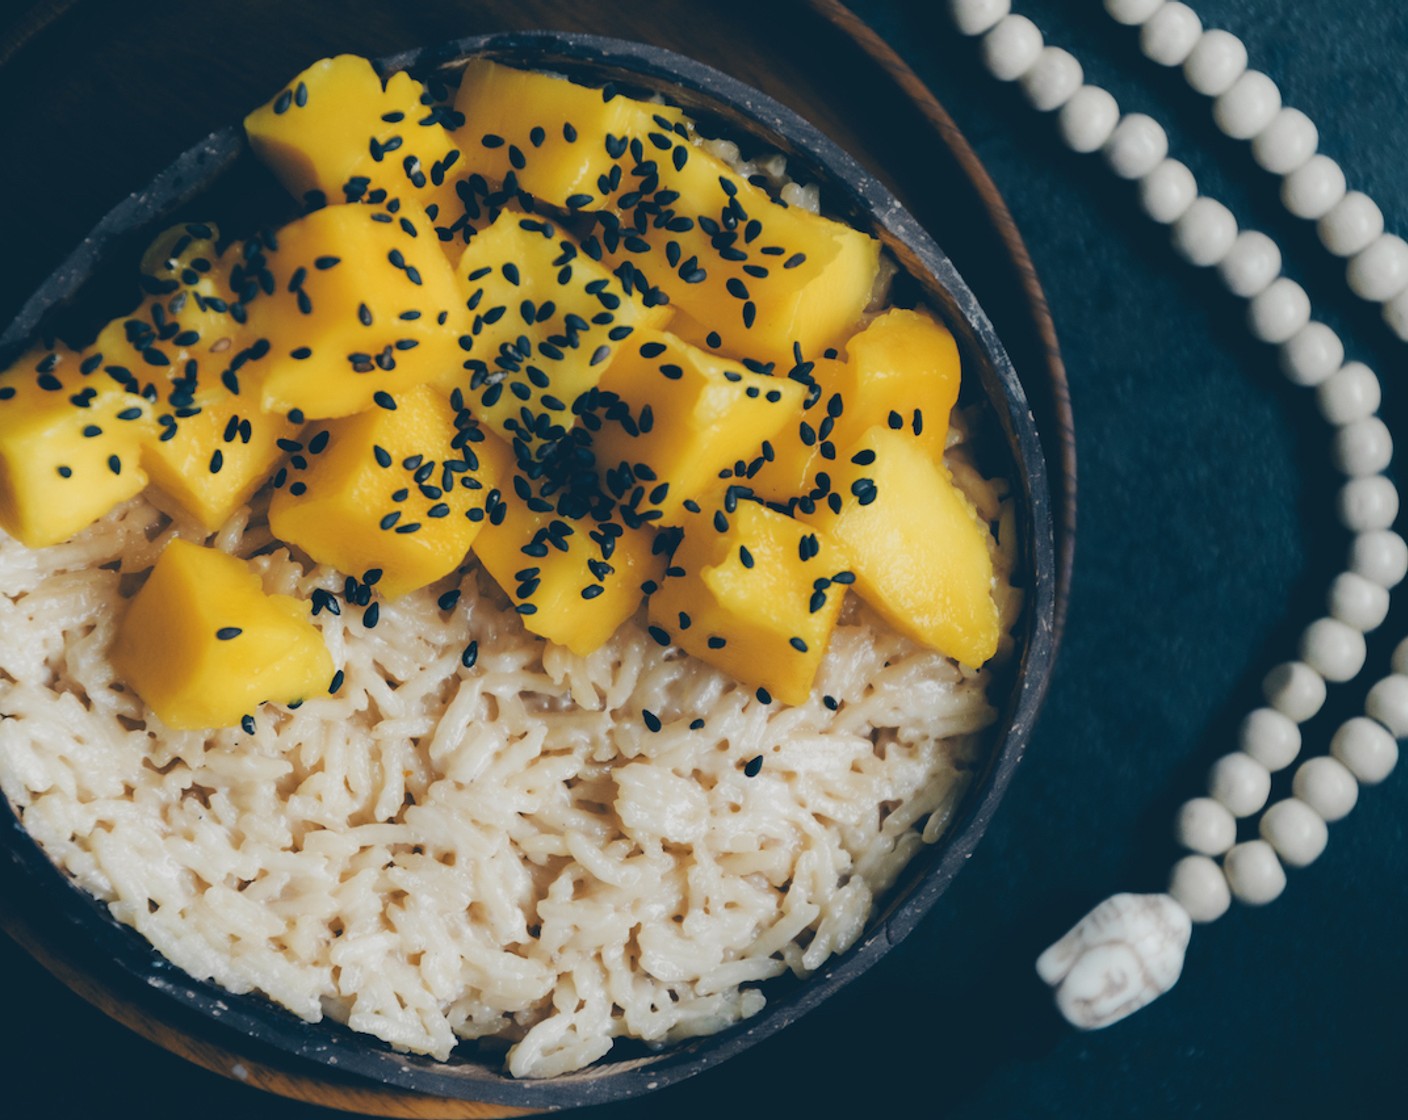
xmin=0 ymin=402 xmax=1019 ymax=1078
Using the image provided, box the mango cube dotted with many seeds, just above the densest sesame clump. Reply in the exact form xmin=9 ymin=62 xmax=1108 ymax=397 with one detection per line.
xmin=436 ymin=210 xmax=670 ymax=441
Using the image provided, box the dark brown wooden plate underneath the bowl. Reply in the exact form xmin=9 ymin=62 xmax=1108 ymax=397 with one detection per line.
xmin=0 ymin=0 xmax=1074 ymax=1117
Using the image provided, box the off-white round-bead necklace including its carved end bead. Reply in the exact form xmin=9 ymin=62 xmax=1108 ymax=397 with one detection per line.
xmin=949 ymin=0 xmax=1408 ymax=1028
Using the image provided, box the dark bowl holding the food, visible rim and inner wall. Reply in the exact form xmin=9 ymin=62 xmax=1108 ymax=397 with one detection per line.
xmin=0 ymin=32 xmax=1056 ymax=1109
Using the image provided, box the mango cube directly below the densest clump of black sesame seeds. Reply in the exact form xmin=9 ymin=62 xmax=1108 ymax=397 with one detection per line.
xmin=474 ymin=480 xmax=666 ymax=657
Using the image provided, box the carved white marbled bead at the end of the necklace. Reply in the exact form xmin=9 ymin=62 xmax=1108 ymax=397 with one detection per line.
xmin=1036 ymin=895 xmax=1193 ymax=1030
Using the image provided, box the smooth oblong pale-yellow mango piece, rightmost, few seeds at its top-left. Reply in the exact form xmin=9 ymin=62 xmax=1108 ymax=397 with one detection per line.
xmin=797 ymin=427 xmax=1000 ymax=666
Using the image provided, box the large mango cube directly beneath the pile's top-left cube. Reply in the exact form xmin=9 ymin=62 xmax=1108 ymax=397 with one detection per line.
xmin=249 ymin=204 xmax=469 ymax=420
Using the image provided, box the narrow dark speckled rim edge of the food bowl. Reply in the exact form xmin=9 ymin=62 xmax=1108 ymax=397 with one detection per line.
xmin=0 ymin=31 xmax=1056 ymax=1109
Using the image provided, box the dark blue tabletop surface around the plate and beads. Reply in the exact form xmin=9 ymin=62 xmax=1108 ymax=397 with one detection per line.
xmin=0 ymin=0 xmax=1408 ymax=1120
